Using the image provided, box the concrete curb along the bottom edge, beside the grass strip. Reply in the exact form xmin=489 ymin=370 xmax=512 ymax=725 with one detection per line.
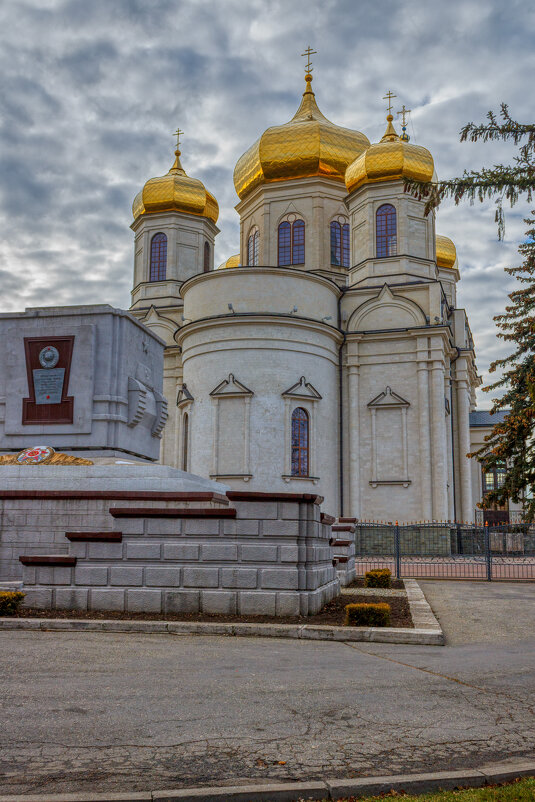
xmin=0 ymin=758 xmax=535 ymax=802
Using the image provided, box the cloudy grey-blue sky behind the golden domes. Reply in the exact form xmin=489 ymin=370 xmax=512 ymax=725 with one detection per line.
xmin=0 ymin=0 xmax=535 ymax=406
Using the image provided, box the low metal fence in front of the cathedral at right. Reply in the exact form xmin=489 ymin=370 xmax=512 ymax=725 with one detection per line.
xmin=355 ymin=522 xmax=535 ymax=581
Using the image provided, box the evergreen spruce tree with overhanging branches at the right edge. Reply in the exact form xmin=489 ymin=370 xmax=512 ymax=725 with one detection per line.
xmin=405 ymin=104 xmax=535 ymax=521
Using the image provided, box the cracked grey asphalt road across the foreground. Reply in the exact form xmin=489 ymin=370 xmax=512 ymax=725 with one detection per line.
xmin=0 ymin=583 xmax=535 ymax=795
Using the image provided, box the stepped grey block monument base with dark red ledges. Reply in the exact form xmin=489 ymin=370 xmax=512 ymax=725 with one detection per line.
xmin=0 ymin=463 xmax=340 ymax=616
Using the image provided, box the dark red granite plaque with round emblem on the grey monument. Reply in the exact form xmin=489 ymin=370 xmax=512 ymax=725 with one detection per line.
xmin=22 ymin=337 xmax=74 ymax=424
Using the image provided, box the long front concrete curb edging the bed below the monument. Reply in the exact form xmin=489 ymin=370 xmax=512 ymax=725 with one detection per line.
xmin=0 ymin=618 xmax=444 ymax=646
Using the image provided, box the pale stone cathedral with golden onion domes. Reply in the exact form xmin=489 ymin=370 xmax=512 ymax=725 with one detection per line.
xmin=130 ymin=65 xmax=490 ymax=522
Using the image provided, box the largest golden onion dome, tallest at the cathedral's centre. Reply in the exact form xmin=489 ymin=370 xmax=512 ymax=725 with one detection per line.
xmin=234 ymin=73 xmax=370 ymax=198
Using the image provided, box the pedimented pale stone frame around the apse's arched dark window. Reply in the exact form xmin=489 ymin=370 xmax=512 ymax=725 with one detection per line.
xmin=281 ymin=376 xmax=322 ymax=485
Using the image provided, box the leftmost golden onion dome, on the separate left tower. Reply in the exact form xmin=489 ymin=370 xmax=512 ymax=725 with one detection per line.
xmin=132 ymin=149 xmax=219 ymax=223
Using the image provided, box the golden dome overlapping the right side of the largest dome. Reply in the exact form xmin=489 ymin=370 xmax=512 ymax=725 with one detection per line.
xmin=345 ymin=114 xmax=434 ymax=192
